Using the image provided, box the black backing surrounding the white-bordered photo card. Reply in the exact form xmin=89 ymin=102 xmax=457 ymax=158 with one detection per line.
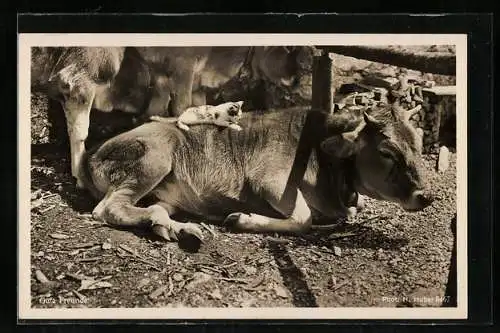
xmin=6 ymin=13 xmax=494 ymax=331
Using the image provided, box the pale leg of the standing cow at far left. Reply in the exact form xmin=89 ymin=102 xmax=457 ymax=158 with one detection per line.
xmin=63 ymin=87 xmax=95 ymax=188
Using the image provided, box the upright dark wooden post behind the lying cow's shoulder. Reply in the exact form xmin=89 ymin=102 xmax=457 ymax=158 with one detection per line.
xmin=312 ymin=50 xmax=335 ymax=113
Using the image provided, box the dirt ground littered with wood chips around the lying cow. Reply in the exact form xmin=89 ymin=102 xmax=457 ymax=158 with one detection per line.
xmin=27 ymin=95 xmax=456 ymax=307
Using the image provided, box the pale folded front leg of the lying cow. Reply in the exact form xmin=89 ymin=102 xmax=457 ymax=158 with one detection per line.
xmin=225 ymin=190 xmax=312 ymax=233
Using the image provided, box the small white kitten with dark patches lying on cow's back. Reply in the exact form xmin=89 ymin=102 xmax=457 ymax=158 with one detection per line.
xmin=150 ymin=101 xmax=243 ymax=131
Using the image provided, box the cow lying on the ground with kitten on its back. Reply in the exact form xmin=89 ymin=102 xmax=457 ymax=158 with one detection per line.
xmin=80 ymin=101 xmax=432 ymax=244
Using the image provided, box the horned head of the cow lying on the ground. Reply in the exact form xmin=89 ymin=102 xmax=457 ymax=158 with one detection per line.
xmin=321 ymin=104 xmax=432 ymax=211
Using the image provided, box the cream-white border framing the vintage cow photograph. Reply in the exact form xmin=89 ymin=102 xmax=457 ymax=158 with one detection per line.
xmin=17 ymin=33 xmax=468 ymax=320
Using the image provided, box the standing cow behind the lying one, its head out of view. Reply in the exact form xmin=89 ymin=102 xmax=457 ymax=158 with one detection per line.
xmin=31 ymin=46 xmax=310 ymax=187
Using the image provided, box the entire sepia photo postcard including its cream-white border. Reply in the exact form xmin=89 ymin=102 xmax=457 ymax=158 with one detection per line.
xmin=18 ymin=34 xmax=467 ymax=319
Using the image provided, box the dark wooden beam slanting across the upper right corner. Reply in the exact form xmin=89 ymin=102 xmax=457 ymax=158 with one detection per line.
xmin=316 ymin=45 xmax=456 ymax=75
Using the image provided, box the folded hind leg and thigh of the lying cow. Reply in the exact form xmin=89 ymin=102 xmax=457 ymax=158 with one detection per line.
xmin=90 ymin=138 xmax=202 ymax=240
